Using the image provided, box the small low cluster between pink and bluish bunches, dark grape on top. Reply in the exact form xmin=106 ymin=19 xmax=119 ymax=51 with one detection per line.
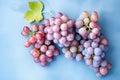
xmin=62 ymin=33 xmax=84 ymax=61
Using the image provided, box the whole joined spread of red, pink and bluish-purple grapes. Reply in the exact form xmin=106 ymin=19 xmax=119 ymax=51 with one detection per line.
xmin=21 ymin=11 xmax=112 ymax=77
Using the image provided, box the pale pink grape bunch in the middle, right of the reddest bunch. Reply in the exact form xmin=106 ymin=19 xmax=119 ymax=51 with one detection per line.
xmin=44 ymin=13 xmax=74 ymax=47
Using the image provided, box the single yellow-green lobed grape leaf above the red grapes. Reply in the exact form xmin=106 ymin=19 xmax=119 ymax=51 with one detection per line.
xmin=24 ymin=1 xmax=44 ymax=23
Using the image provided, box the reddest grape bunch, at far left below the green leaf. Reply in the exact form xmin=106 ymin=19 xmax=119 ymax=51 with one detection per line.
xmin=21 ymin=24 xmax=60 ymax=67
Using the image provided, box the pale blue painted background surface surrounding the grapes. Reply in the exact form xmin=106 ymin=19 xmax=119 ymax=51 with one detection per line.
xmin=0 ymin=0 xmax=120 ymax=80
